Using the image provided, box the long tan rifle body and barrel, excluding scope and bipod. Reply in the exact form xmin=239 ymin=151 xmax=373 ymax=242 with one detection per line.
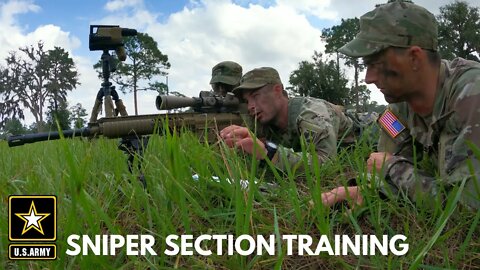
xmin=7 ymin=113 xmax=244 ymax=147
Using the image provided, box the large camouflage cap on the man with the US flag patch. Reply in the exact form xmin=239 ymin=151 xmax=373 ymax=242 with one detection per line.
xmin=338 ymin=0 xmax=438 ymax=57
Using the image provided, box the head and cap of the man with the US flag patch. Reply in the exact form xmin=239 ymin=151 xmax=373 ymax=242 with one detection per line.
xmin=338 ymin=0 xmax=440 ymax=103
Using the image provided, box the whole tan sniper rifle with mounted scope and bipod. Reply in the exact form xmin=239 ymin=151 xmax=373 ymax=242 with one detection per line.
xmin=7 ymin=91 xmax=246 ymax=187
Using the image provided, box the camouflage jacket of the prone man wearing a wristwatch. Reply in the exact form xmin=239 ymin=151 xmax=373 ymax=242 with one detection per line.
xmin=265 ymin=97 xmax=353 ymax=170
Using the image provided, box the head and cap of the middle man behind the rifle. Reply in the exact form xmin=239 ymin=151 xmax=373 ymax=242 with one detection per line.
xmin=233 ymin=67 xmax=288 ymax=124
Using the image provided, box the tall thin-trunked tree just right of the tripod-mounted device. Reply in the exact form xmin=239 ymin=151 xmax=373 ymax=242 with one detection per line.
xmin=94 ymin=33 xmax=170 ymax=115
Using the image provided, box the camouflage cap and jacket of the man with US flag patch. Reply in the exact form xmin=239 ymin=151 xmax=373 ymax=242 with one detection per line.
xmin=339 ymin=0 xmax=480 ymax=209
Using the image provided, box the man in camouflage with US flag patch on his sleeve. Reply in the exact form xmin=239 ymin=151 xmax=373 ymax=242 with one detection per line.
xmin=323 ymin=1 xmax=480 ymax=209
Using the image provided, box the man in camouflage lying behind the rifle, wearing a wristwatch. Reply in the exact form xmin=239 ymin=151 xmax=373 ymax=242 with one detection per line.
xmin=220 ymin=67 xmax=353 ymax=173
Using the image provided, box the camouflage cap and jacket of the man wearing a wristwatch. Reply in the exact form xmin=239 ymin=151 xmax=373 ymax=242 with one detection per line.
xmin=233 ymin=67 xmax=354 ymax=173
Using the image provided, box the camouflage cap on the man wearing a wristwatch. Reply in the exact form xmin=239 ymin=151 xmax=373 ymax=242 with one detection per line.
xmin=233 ymin=67 xmax=282 ymax=95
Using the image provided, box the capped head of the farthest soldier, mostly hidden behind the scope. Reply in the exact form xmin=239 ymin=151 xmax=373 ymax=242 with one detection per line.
xmin=210 ymin=61 xmax=242 ymax=96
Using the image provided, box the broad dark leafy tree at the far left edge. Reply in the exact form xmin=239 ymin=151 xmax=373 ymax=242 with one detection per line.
xmin=0 ymin=41 xmax=78 ymax=131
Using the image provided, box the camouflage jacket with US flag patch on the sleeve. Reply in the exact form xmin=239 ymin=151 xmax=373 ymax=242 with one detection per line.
xmin=378 ymin=58 xmax=480 ymax=209
